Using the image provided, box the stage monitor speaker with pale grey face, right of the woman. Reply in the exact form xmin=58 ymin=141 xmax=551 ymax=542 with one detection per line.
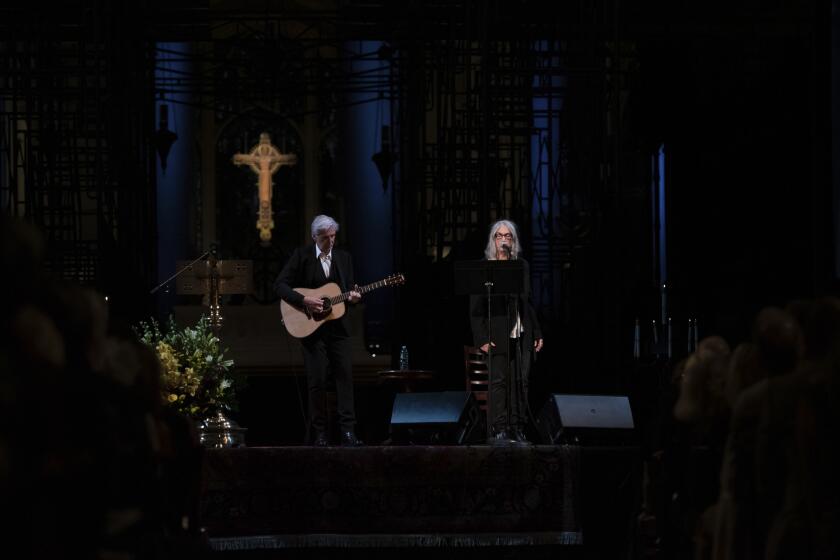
xmin=537 ymin=394 xmax=634 ymax=444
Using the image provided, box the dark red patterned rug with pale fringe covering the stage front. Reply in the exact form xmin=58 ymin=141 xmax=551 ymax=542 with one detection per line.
xmin=201 ymin=445 xmax=638 ymax=552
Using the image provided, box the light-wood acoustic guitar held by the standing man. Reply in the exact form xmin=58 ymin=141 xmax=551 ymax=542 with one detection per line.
xmin=280 ymin=274 xmax=405 ymax=338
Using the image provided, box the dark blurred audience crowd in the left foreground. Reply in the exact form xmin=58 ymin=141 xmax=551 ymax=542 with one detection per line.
xmin=0 ymin=216 xmax=208 ymax=558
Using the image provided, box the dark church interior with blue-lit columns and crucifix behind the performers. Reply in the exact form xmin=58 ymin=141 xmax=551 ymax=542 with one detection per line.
xmin=0 ymin=0 xmax=840 ymax=557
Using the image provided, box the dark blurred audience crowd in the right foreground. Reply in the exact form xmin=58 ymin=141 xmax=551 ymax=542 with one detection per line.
xmin=673 ymin=298 xmax=840 ymax=560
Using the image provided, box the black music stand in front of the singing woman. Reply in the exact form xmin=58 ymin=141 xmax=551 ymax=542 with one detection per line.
xmin=455 ymin=260 xmax=525 ymax=440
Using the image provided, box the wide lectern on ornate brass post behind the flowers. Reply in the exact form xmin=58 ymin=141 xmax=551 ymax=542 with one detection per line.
xmin=175 ymin=255 xmax=254 ymax=331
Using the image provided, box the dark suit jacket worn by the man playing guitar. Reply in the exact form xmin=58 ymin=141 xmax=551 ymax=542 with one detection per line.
xmin=274 ymin=244 xmax=355 ymax=336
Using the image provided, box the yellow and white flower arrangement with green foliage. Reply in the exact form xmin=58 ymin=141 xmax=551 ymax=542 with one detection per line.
xmin=135 ymin=316 xmax=236 ymax=418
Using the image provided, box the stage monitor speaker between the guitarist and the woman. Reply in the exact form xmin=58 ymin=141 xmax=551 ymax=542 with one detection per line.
xmin=390 ymin=391 xmax=484 ymax=445
